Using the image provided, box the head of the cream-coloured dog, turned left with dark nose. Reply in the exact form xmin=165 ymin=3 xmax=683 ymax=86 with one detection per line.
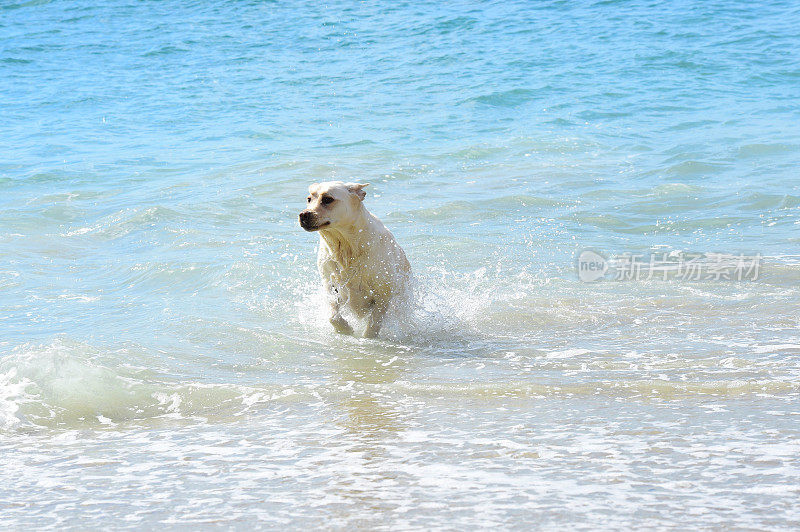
xmin=300 ymin=181 xmax=367 ymax=231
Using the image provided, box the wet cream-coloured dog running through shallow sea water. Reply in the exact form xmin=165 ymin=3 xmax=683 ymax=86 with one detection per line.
xmin=299 ymin=181 xmax=411 ymax=338
